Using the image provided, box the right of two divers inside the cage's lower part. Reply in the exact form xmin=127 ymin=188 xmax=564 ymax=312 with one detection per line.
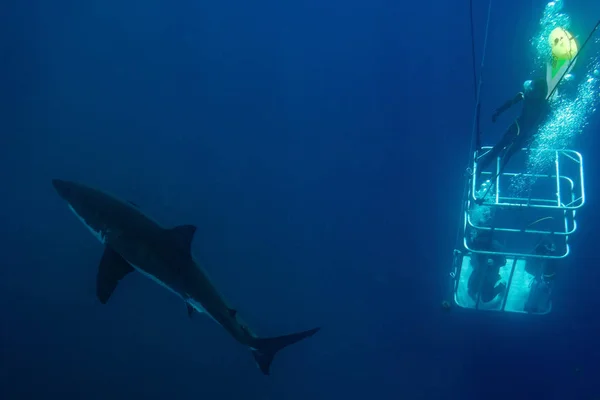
xmin=525 ymin=241 xmax=558 ymax=313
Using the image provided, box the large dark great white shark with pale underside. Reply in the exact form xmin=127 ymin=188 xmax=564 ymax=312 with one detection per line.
xmin=52 ymin=179 xmax=320 ymax=375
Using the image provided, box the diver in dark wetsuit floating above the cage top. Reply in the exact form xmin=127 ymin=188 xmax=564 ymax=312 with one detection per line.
xmin=477 ymin=79 xmax=550 ymax=182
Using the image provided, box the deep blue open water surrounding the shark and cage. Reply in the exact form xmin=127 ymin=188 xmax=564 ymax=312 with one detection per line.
xmin=0 ymin=0 xmax=600 ymax=400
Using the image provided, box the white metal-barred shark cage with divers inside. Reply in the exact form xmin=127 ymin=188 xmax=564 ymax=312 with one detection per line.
xmin=446 ymin=147 xmax=585 ymax=314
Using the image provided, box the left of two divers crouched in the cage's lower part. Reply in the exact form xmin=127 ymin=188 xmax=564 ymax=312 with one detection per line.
xmin=468 ymin=231 xmax=506 ymax=303
